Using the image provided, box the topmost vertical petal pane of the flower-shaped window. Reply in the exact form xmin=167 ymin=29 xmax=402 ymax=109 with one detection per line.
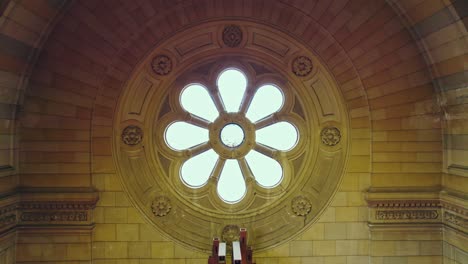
xmin=218 ymin=69 xmax=247 ymax=112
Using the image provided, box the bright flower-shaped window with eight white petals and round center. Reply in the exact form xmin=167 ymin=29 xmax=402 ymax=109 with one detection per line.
xmin=165 ymin=69 xmax=298 ymax=204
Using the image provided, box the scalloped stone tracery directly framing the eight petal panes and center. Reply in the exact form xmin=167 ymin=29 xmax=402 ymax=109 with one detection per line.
xmin=153 ymin=60 xmax=302 ymax=210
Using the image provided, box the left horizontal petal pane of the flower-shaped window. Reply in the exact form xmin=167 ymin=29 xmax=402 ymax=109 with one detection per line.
xmin=165 ymin=122 xmax=208 ymax=150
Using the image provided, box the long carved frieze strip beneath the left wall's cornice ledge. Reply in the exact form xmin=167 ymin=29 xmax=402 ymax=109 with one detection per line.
xmin=21 ymin=211 xmax=88 ymax=222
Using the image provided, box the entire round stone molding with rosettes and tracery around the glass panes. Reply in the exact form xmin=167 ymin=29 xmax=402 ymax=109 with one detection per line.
xmin=112 ymin=20 xmax=349 ymax=252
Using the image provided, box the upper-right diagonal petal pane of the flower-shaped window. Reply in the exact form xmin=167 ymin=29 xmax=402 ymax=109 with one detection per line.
xmin=246 ymin=84 xmax=284 ymax=122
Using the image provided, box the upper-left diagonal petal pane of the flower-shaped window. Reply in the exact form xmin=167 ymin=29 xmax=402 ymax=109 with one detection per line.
xmin=180 ymin=84 xmax=219 ymax=122
